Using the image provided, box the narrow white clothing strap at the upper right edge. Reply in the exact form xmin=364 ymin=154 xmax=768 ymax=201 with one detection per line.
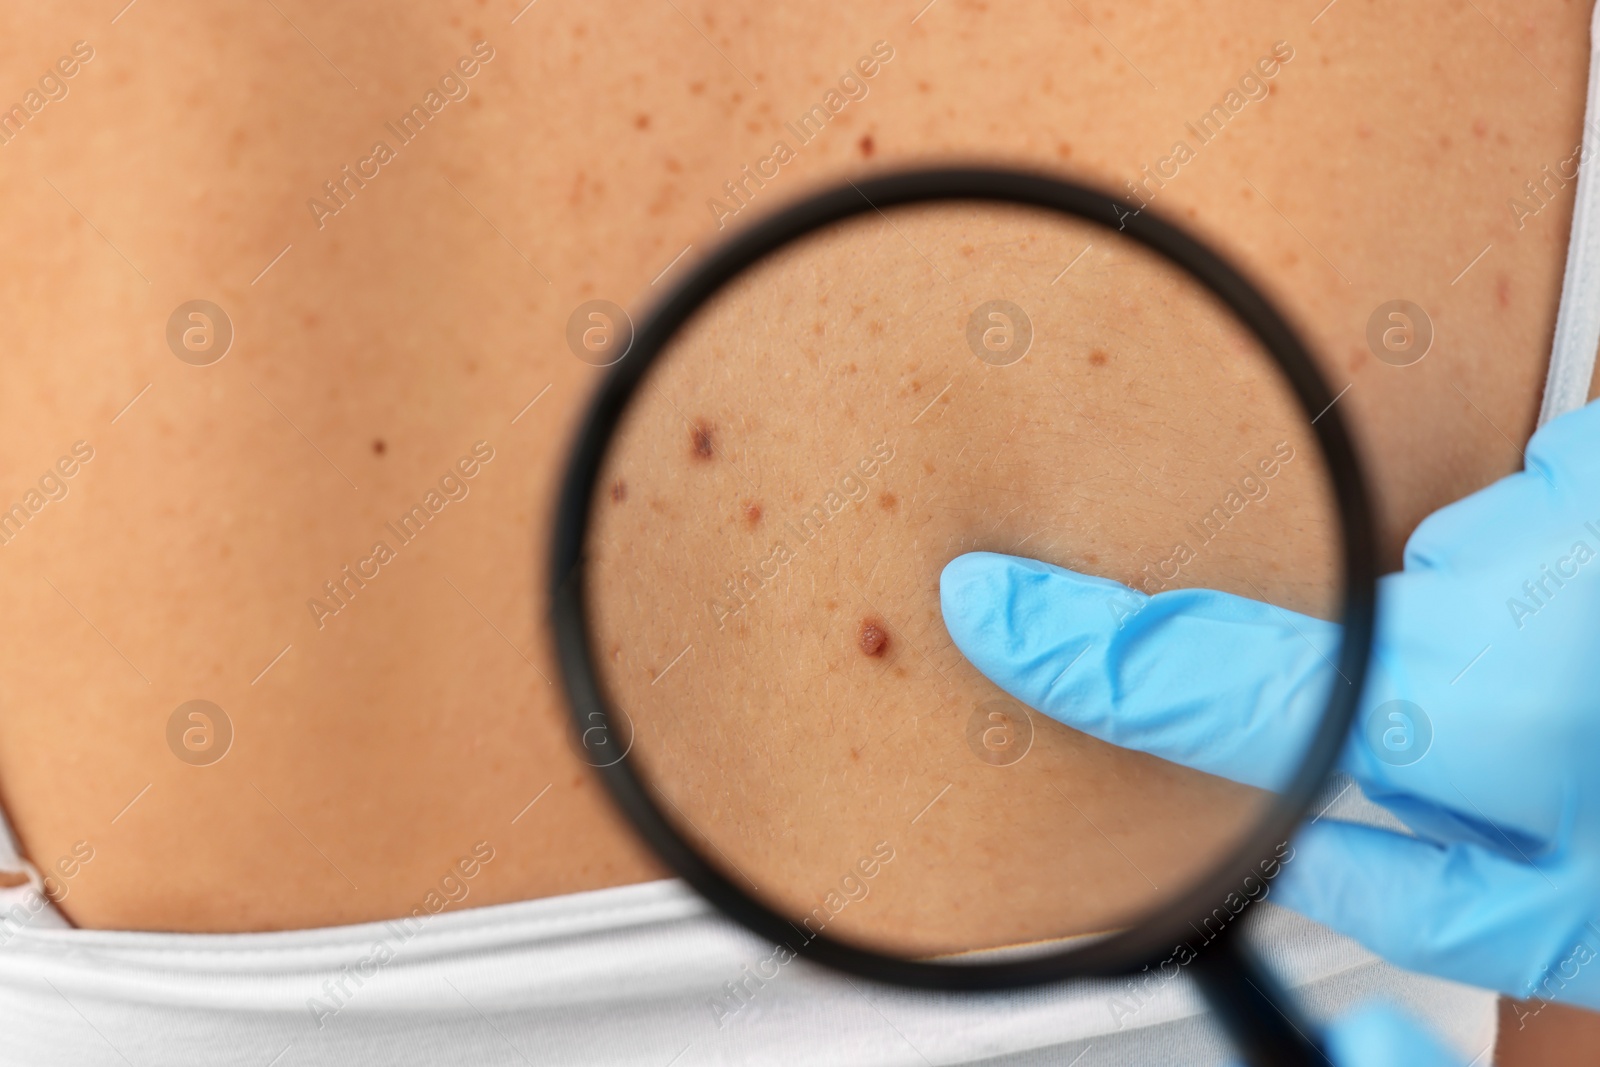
xmin=1539 ymin=5 xmax=1600 ymax=426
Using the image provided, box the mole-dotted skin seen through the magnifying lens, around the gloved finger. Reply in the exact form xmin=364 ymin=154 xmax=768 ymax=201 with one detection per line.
xmin=589 ymin=203 xmax=1339 ymax=955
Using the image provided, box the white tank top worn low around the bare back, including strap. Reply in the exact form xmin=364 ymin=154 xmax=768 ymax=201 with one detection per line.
xmin=15 ymin=6 xmax=1600 ymax=1049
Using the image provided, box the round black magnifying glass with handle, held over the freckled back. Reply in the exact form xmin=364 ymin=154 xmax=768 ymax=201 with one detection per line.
xmin=552 ymin=170 xmax=1376 ymax=1064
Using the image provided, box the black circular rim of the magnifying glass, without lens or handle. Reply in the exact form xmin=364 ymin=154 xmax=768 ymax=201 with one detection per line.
xmin=550 ymin=168 xmax=1378 ymax=990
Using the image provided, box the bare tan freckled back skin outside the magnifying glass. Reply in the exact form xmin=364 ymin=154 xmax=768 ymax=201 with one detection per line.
xmin=0 ymin=0 xmax=1589 ymax=1062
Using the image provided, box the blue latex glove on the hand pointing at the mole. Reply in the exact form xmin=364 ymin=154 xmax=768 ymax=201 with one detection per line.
xmin=941 ymin=405 xmax=1600 ymax=1008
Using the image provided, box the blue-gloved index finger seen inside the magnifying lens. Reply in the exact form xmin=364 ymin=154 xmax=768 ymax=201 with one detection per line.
xmin=939 ymin=552 xmax=1349 ymax=789
